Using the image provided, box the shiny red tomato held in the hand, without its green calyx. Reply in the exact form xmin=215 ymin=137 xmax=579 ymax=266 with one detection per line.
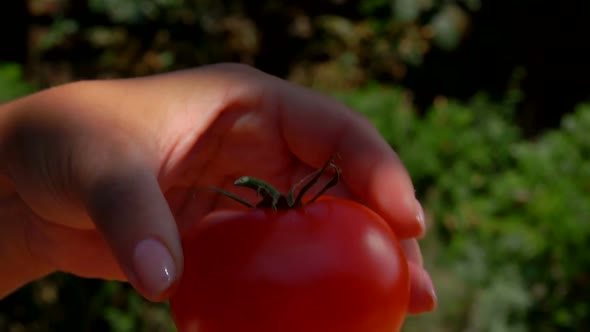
xmin=170 ymin=197 xmax=409 ymax=332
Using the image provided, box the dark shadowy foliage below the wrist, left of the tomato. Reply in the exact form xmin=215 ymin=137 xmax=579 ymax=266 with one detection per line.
xmin=0 ymin=273 xmax=175 ymax=332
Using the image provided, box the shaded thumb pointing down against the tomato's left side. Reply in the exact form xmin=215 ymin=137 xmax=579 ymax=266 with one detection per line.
xmin=83 ymin=167 xmax=183 ymax=301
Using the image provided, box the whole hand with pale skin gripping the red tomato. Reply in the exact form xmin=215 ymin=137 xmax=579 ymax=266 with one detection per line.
xmin=0 ymin=64 xmax=436 ymax=313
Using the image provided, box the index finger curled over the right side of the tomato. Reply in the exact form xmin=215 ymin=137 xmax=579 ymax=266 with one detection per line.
xmin=278 ymin=83 xmax=424 ymax=238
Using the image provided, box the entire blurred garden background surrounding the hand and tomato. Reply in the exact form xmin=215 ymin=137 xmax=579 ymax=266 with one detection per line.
xmin=0 ymin=0 xmax=590 ymax=332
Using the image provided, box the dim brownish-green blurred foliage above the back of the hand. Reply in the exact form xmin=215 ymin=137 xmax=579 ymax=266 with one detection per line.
xmin=29 ymin=0 xmax=477 ymax=88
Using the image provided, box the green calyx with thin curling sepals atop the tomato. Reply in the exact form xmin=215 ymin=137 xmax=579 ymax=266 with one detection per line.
xmin=211 ymin=157 xmax=340 ymax=211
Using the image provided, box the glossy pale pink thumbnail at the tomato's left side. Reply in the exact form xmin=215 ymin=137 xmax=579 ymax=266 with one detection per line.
xmin=133 ymin=239 xmax=176 ymax=297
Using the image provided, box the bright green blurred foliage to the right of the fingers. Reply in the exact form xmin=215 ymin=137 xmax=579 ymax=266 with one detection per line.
xmin=341 ymin=88 xmax=590 ymax=332
